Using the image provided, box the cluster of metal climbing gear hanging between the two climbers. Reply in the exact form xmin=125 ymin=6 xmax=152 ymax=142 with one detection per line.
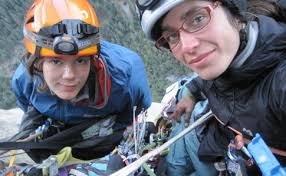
xmin=113 ymin=104 xmax=171 ymax=176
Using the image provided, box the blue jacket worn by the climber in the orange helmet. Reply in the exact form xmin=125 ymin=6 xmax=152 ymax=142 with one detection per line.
xmin=12 ymin=41 xmax=151 ymax=123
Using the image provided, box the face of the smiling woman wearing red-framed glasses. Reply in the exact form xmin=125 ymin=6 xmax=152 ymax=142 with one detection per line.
xmin=161 ymin=1 xmax=240 ymax=80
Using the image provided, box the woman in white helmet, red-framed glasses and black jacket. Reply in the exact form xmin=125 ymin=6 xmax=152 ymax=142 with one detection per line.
xmin=136 ymin=0 xmax=286 ymax=175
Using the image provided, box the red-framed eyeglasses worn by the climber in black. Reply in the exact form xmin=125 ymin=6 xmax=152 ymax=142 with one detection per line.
xmin=155 ymin=2 xmax=219 ymax=49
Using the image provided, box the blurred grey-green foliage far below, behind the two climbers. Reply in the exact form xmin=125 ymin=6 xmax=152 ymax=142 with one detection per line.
xmin=0 ymin=0 xmax=190 ymax=108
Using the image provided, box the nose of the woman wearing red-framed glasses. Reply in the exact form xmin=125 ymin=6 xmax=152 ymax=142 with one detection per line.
xmin=179 ymin=30 xmax=200 ymax=52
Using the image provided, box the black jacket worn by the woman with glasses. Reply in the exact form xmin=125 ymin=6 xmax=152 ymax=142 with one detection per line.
xmin=188 ymin=16 xmax=286 ymax=165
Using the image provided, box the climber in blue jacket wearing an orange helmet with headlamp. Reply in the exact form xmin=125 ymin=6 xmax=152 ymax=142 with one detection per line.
xmin=12 ymin=0 xmax=151 ymax=168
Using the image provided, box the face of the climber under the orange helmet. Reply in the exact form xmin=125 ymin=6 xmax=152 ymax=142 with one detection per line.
xmin=43 ymin=56 xmax=91 ymax=100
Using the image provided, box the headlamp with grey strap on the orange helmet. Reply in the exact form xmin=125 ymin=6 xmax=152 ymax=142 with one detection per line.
xmin=23 ymin=20 xmax=99 ymax=55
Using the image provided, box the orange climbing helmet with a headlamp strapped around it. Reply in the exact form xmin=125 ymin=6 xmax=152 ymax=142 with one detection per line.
xmin=23 ymin=0 xmax=99 ymax=57
